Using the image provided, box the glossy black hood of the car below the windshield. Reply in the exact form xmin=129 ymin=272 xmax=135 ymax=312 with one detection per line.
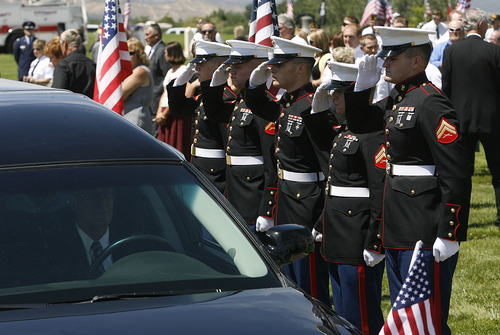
xmin=0 ymin=288 xmax=357 ymax=335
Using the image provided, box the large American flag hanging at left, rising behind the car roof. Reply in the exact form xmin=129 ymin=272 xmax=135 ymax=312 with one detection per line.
xmin=94 ymin=0 xmax=132 ymax=114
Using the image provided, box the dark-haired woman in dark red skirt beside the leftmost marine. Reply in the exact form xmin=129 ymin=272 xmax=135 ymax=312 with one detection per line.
xmin=155 ymin=42 xmax=191 ymax=159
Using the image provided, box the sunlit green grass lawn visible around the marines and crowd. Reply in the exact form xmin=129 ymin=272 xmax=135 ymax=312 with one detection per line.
xmin=0 ymin=51 xmax=500 ymax=335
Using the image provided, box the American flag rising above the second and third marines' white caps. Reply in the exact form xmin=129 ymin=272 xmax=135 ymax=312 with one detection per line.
xmin=248 ymin=0 xmax=279 ymax=47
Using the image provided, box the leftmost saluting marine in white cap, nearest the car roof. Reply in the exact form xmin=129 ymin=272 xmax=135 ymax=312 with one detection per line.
xmin=167 ymin=41 xmax=232 ymax=193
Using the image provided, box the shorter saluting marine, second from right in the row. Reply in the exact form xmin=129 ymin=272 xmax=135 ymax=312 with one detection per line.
xmin=304 ymin=62 xmax=386 ymax=334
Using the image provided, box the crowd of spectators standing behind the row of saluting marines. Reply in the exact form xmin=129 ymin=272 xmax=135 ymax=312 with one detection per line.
xmin=14 ymin=9 xmax=500 ymax=226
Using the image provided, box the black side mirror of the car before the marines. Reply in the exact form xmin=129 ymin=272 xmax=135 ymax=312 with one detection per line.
xmin=257 ymin=224 xmax=314 ymax=265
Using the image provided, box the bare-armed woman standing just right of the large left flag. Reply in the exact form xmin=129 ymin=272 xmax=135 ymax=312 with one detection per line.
xmin=122 ymin=38 xmax=153 ymax=134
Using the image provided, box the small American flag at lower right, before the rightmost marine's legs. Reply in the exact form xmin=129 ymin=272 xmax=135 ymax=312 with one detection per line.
xmin=379 ymin=241 xmax=439 ymax=335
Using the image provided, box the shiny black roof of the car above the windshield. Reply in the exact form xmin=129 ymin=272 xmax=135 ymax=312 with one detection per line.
xmin=0 ymin=79 xmax=182 ymax=167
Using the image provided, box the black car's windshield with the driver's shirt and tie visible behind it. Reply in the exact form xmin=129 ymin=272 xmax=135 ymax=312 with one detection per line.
xmin=0 ymin=164 xmax=280 ymax=304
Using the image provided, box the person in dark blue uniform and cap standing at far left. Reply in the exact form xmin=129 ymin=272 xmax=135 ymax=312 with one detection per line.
xmin=14 ymin=21 xmax=36 ymax=81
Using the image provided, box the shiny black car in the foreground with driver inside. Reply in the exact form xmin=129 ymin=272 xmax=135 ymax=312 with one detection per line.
xmin=0 ymin=79 xmax=360 ymax=334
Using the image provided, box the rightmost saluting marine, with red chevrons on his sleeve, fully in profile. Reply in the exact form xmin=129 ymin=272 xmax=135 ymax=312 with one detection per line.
xmin=346 ymin=27 xmax=471 ymax=334
